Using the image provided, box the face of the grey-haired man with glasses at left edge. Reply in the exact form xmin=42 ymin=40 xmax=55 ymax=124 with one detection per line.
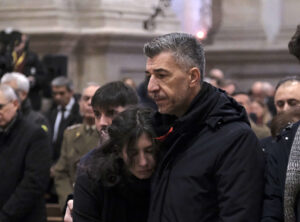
xmin=0 ymin=91 xmax=18 ymax=127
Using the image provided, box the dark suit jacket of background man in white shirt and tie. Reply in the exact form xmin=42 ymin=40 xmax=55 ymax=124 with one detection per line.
xmin=47 ymin=101 xmax=82 ymax=163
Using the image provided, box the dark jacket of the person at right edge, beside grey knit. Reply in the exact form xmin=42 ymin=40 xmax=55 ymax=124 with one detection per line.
xmin=261 ymin=121 xmax=300 ymax=222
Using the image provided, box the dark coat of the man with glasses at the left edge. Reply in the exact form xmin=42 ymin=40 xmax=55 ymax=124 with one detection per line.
xmin=0 ymin=115 xmax=51 ymax=222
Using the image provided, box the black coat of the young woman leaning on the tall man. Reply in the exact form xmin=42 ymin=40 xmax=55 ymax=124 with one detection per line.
xmin=73 ymin=151 xmax=150 ymax=222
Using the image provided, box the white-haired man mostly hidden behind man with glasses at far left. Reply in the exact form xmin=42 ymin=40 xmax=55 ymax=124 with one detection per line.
xmin=1 ymin=72 xmax=48 ymax=131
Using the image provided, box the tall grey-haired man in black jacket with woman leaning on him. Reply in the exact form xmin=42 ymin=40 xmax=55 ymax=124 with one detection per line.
xmin=144 ymin=33 xmax=264 ymax=222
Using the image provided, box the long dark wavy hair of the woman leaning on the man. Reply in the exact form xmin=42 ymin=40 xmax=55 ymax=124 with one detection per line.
xmin=84 ymin=106 xmax=158 ymax=187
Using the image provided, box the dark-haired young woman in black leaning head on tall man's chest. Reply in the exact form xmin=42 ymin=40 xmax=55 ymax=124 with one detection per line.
xmin=72 ymin=108 xmax=158 ymax=222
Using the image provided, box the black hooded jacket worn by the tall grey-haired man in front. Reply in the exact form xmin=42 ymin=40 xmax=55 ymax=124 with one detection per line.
xmin=148 ymin=83 xmax=264 ymax=222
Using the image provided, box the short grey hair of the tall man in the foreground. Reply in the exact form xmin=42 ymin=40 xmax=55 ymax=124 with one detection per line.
xmin=144 ymin=33 xmax=205 ymax=83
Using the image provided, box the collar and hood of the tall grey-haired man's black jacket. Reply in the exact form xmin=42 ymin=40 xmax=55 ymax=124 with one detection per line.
xmin=153 ymin=82 xmax=250 ymax=140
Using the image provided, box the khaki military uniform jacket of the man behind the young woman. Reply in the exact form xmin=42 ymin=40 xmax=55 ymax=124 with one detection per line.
xmin=54 ymin=124 xmax=99 ymax=209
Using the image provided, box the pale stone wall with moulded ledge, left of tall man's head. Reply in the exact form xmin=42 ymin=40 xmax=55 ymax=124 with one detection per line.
xmin=0 ymin=0 xmax=179 ymax=91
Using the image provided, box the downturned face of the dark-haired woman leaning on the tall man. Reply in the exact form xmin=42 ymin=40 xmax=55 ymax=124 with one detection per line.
xmin=122 ymin=133 xmax=156 ymax=179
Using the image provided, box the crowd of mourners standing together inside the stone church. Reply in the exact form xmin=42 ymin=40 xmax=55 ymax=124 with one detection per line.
xmin=0 ymin=26 xmax=300 ymax=222
